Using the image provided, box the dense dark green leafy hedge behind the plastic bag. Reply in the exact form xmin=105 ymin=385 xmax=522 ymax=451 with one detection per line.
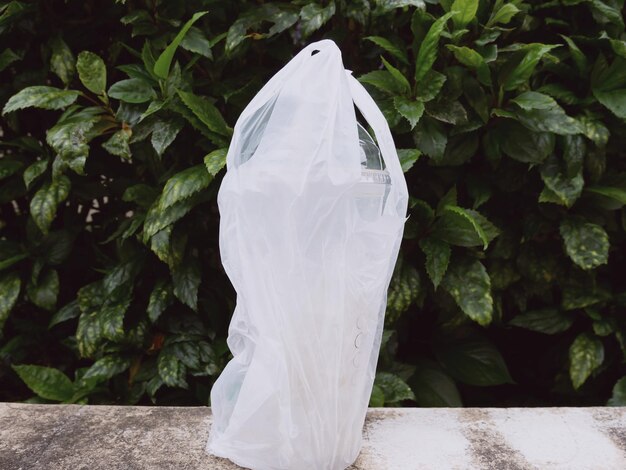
xmin=0 ymin=0 xmax=626 ymax=406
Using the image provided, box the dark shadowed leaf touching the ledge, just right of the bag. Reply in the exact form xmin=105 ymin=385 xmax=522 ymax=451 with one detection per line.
xmin=409 ymin=360 xmax=463 ymax=407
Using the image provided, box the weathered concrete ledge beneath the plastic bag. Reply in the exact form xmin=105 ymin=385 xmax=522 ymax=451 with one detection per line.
xmin=0 ymin=403 xmax=626 ymax=470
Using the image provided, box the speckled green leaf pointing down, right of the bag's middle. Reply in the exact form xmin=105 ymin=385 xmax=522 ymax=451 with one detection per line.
xmin=441 ymin=259 xmax=493 ymax=326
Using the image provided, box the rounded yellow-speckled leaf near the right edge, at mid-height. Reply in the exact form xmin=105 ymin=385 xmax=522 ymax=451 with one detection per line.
xmin=559 ymin=217 xmax=609 ymax=269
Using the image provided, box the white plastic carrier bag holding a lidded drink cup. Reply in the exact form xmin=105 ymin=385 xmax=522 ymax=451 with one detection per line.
xmin=207 ymin=40 xmax=408 ymax=470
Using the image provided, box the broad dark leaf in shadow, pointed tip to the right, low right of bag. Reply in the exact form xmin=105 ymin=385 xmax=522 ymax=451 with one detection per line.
xmin=435 ymin=337 xmax=515 ymax=387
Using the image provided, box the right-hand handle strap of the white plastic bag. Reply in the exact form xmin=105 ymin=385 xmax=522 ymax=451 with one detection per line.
xmin=346 ymin=70 xmax=408 ymax=206
